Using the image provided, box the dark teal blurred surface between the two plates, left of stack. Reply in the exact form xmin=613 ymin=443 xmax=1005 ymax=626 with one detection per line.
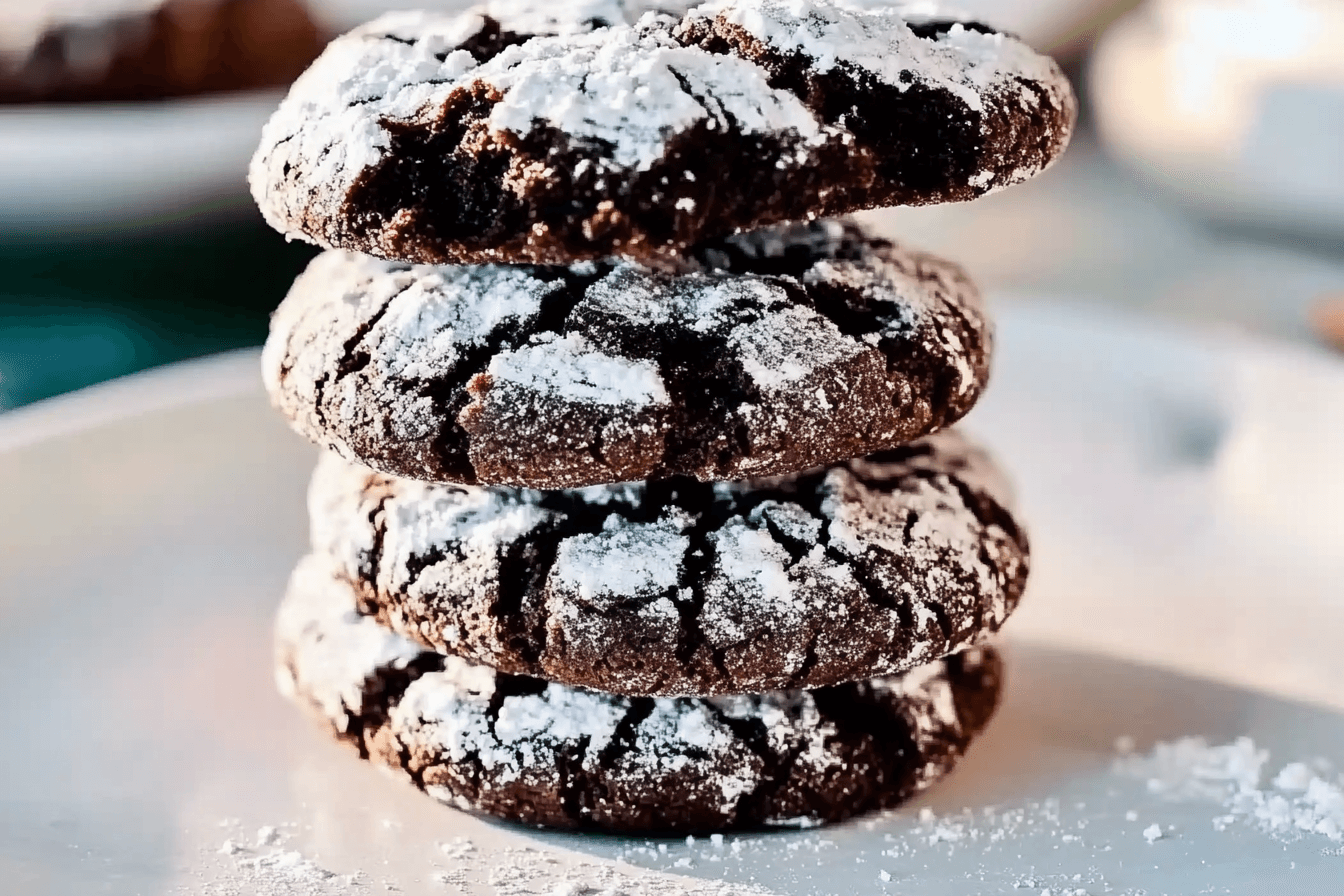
xmin=0 ymin=218 xmax=314 ymax=410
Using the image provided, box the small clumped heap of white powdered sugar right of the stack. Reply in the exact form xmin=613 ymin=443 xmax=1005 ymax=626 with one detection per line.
xmin=1114 ymin=737 xmax=1344 ymax=842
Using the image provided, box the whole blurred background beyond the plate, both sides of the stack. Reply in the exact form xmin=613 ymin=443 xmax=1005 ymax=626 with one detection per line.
xmin=0 ymin=0 xmax=1344 ymax=410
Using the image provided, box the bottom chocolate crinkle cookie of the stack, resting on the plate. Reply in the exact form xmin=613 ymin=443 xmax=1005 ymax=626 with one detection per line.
xmin=277 ymin=557 xmax=1001 ymax=834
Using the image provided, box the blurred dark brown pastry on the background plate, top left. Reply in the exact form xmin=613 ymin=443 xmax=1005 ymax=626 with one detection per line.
xmin=0 ymin=0 xmax=328 ymax=103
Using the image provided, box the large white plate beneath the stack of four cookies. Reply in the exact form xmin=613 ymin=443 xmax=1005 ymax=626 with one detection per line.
xmin=0 ymin=304 xmax=1344 ymax=896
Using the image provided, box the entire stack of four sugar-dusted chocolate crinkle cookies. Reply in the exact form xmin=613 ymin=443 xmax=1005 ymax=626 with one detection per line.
xmin=251 ymin=0 xmax=1074 ymax=833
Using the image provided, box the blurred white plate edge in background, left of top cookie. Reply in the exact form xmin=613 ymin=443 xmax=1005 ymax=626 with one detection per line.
xmin=0 ymin=90 xmax=284 ymax=236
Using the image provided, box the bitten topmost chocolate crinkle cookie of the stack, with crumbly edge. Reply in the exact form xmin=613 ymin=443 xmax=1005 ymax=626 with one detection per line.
xmin=250 ymin=0 xmax=1075 ymax=263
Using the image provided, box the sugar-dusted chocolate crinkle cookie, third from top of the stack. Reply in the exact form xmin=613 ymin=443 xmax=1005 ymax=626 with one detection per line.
xmin=309 ymin=431 xmax=1028 ymax=696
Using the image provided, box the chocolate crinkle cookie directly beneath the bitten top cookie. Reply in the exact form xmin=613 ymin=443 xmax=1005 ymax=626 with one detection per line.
xmin=263 ymin=222 xmax=991 ymax=488
